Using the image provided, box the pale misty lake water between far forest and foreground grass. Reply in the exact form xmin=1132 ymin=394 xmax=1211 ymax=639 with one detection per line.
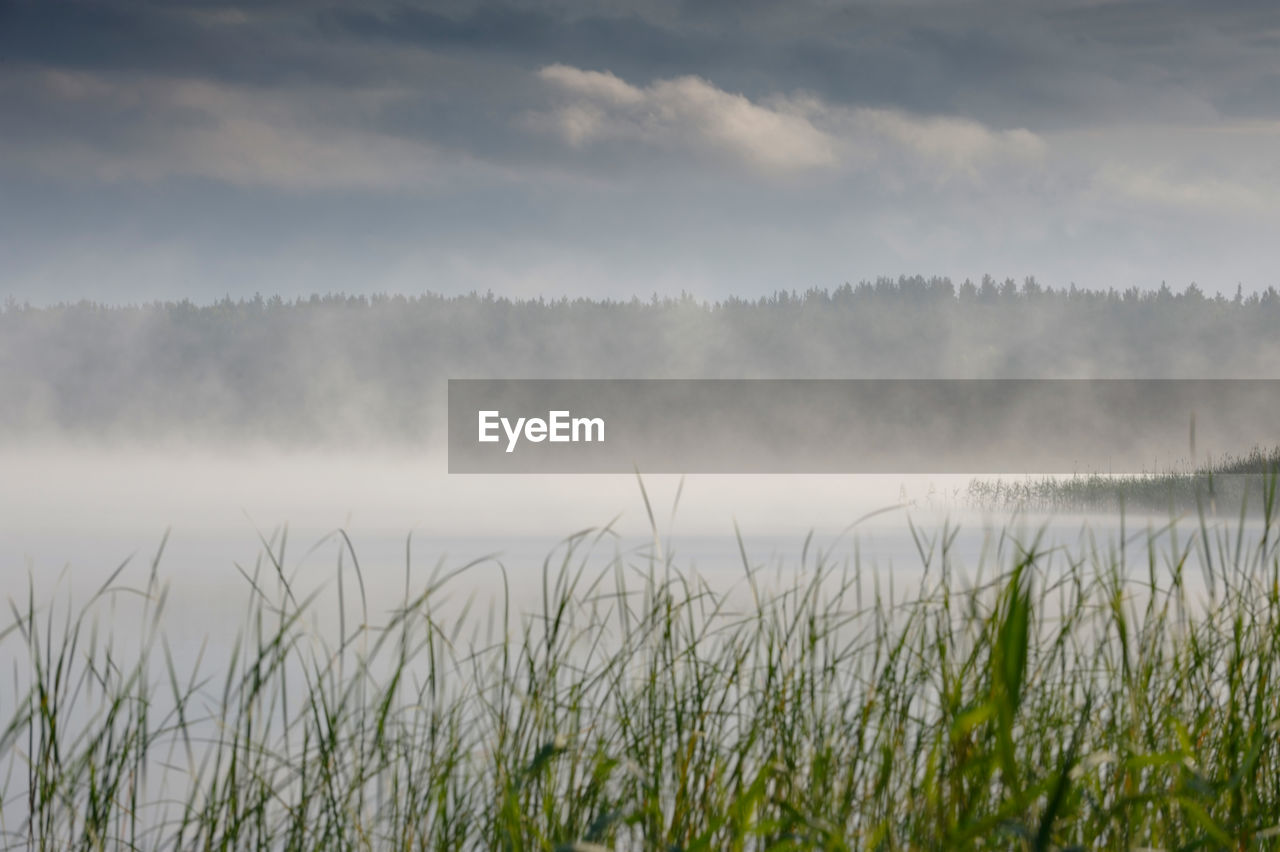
xmin=0 ymin=448 xmax=1269 ymax=642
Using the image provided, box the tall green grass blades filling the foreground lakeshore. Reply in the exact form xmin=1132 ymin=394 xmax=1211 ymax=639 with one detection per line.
xmin=0 ymin=480 xmax=1280 ymax=851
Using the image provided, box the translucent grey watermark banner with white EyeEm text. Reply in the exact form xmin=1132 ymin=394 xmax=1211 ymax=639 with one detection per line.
xmin=448 ymin=379 xmax=1280 ymax=473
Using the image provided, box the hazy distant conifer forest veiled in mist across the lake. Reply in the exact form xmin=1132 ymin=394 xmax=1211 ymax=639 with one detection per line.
xmin=0 ymin=276 xmax=1280 ymax=444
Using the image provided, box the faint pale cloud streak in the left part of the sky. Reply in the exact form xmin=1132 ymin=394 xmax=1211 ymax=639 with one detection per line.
xmin=10 ymin=72 xmax=440 ymax=191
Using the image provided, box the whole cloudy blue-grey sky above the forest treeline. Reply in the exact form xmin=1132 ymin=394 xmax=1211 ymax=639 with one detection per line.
xmin=0 ymin=0 xmax=1280 ymax=303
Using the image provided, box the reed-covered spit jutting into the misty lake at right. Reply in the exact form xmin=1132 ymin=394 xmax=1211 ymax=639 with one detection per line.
xmin=964 ymin=446 xmax=1280 ymax=516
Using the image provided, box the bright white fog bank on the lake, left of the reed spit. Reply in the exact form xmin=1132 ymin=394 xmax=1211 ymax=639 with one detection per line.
xmin=0 ymin=446 xmax=966 ymax=587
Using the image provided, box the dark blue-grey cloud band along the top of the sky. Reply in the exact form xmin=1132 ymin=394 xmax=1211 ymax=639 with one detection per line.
xmin=0 ymin=0 xmax=1280 ymax=127
